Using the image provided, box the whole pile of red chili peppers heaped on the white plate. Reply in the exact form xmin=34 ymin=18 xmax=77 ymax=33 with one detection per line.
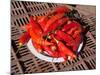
xmin=19 ymin=6 xmax=82 ymax=61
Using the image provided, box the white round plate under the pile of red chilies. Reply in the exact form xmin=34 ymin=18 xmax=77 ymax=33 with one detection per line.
xmin=27 ymin=39 xmax=83 ymax=62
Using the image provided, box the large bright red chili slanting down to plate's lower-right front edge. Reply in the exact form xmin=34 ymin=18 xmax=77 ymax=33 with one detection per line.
xmin=54 ymin=38 xmax=76 ymax=59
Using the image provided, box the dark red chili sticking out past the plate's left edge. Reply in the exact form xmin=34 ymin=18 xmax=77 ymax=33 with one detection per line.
xmin=19 ymin=32 xmax=30 ymax=45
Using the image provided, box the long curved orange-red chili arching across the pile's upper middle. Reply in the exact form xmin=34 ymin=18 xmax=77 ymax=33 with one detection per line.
xmin=44 ymin=13 xmax=64 ymax=31
